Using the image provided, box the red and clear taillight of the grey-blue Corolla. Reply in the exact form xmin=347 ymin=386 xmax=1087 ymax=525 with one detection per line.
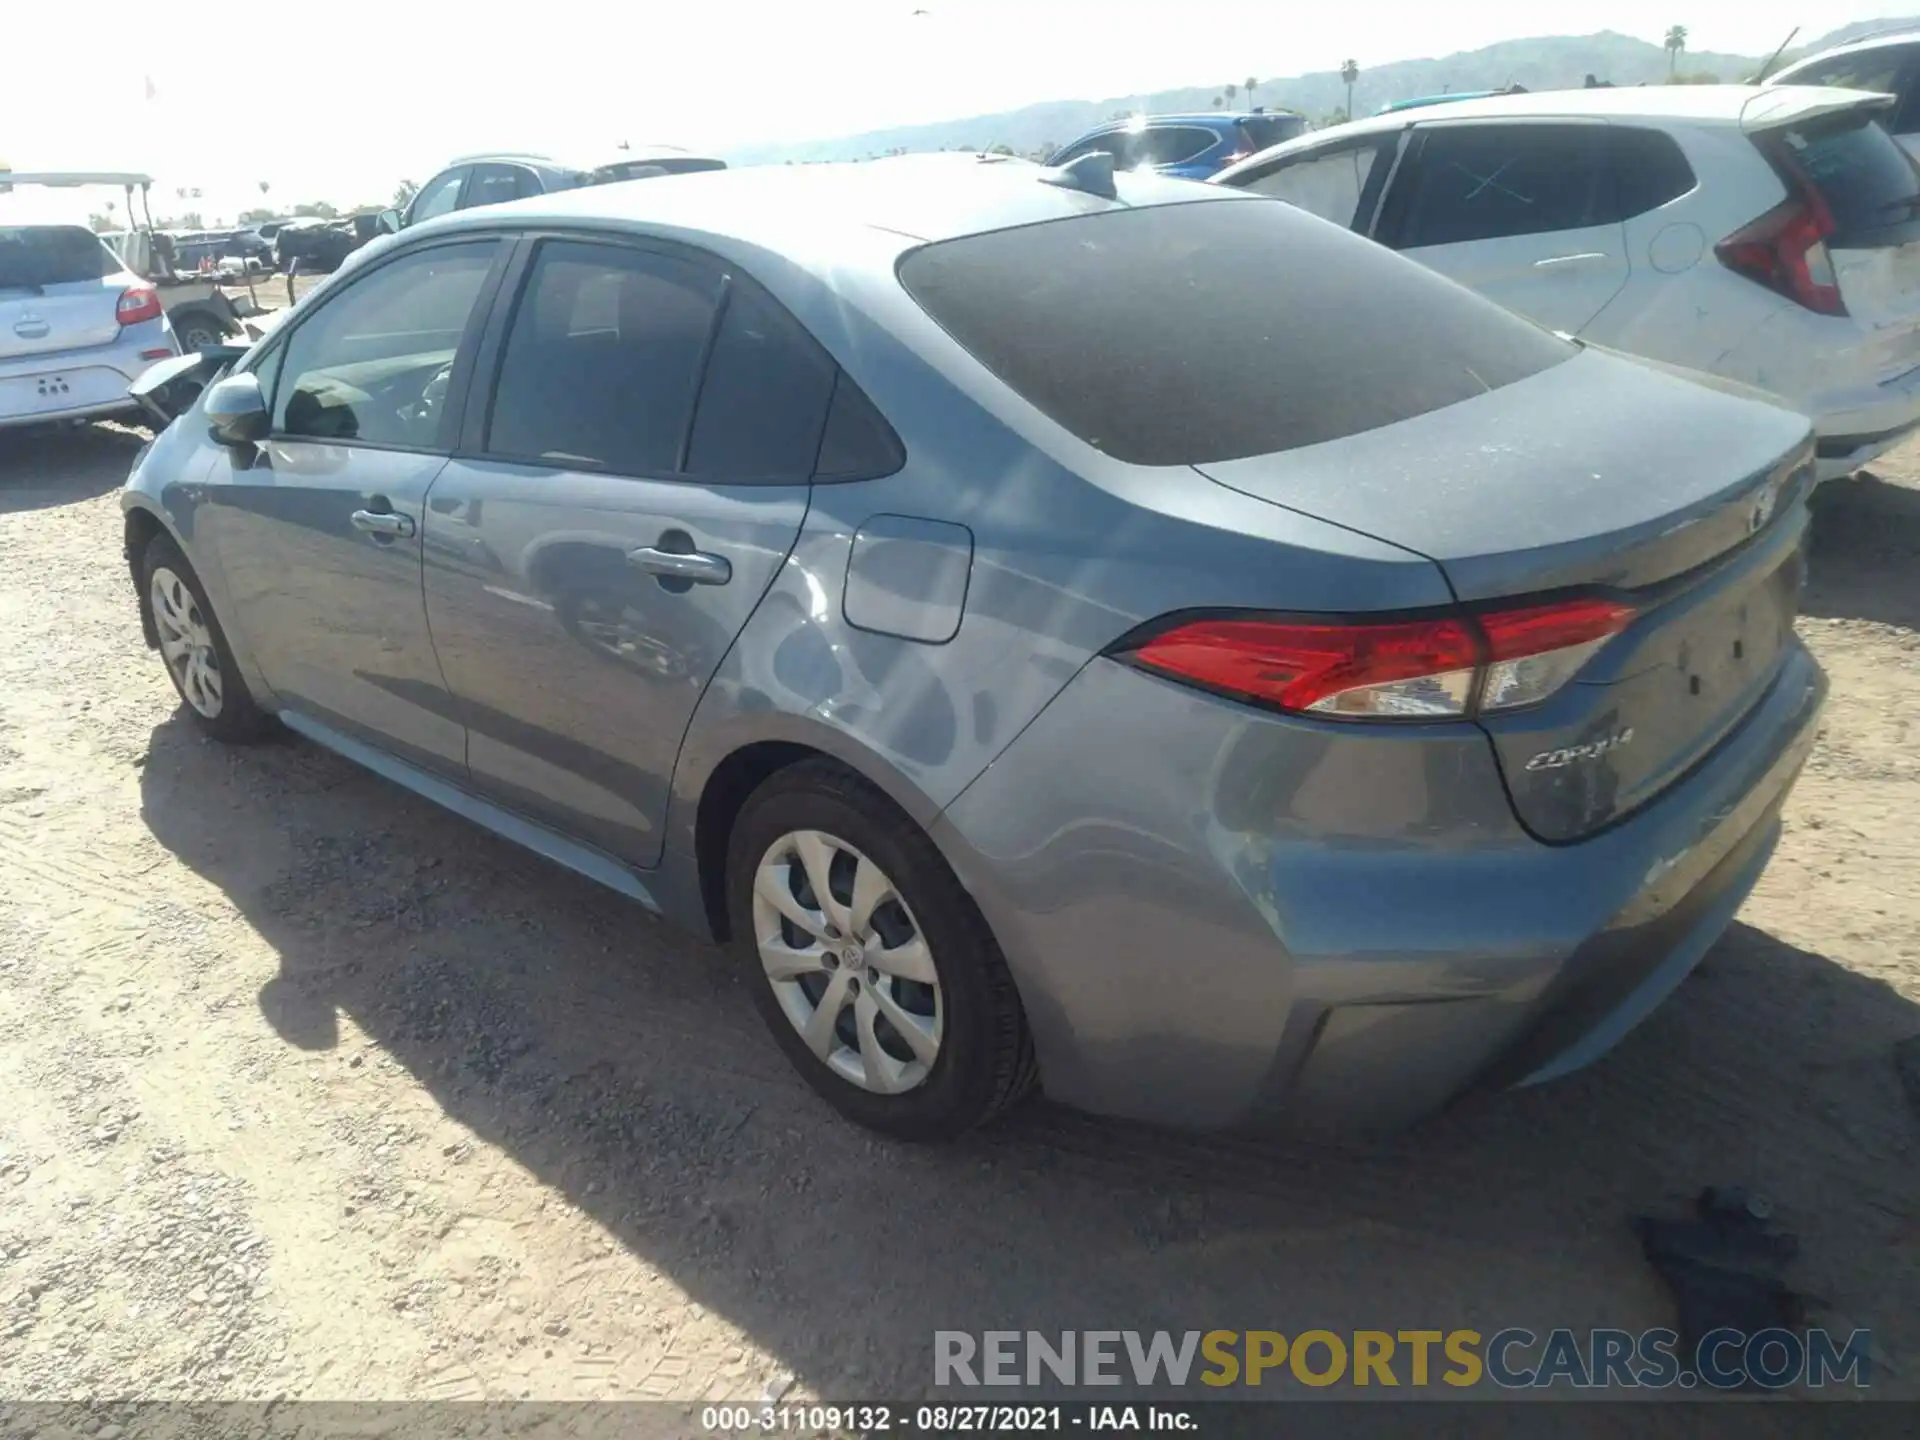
xmin=1121 ymin=599 xmax=1634 ymax=720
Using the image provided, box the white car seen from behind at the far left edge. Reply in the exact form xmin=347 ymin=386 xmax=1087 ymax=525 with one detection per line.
xmin=0 ymin=223 xmax=180 ymax=428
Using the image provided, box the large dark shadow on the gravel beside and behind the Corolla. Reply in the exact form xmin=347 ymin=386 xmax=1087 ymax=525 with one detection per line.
xmin=140 ymin=718 xmax=1920 ymax=1396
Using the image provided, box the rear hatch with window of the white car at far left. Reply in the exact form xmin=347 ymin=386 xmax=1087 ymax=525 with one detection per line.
xmin=0 ymin=225 xmax=132 ymax=359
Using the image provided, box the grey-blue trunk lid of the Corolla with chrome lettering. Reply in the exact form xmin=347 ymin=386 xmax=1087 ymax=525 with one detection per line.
xmin=1198 ymin=351 xmax=1811 ymax=843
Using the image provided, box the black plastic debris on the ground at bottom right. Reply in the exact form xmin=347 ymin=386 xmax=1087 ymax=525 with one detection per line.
xmin=1634 ymin=1187 xmax=1807 ymax=1371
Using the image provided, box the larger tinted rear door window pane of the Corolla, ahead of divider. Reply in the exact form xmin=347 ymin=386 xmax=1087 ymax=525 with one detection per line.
xmin=486 ymin=240 xmax=720 ymax=476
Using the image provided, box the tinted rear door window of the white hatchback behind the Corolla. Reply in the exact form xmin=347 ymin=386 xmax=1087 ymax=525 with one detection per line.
xmin=1380 ymin=125 xmax=1613 ymax=250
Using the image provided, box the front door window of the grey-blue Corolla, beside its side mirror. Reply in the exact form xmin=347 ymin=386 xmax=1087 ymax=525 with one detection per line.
xmin=273 ymin=242 xmax=497 ymax=449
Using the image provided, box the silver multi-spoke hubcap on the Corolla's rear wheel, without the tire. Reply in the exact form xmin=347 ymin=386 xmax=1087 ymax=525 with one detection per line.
xmin=753 ymin=829 xmax=945 ymax=1094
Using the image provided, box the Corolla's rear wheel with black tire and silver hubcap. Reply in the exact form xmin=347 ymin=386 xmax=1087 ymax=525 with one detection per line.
xmin=728 ymin=760 xmax=1035 ymax=1140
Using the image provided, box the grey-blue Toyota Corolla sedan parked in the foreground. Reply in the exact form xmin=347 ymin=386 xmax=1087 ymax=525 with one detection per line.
xmin=123 ymin=156 xmax=1824 ymax=1137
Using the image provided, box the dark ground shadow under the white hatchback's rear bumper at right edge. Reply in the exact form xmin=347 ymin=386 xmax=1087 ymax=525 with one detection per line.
xmin=1801 ymin=472 xmax=1920 ymax=630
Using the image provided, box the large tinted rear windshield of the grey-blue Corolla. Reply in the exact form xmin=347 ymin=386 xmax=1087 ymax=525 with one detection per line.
xmin=899 ymin=198 xmax=1574 ymax=465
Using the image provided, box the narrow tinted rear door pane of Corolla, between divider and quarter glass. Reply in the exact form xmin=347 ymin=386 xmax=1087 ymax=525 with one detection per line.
xmin=687 ymin=280 xmax=835 ymax=484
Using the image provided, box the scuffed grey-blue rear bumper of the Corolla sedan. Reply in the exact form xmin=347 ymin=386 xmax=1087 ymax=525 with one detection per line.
xmin=935 ymin=643 xmax=1826 ymax=1129
